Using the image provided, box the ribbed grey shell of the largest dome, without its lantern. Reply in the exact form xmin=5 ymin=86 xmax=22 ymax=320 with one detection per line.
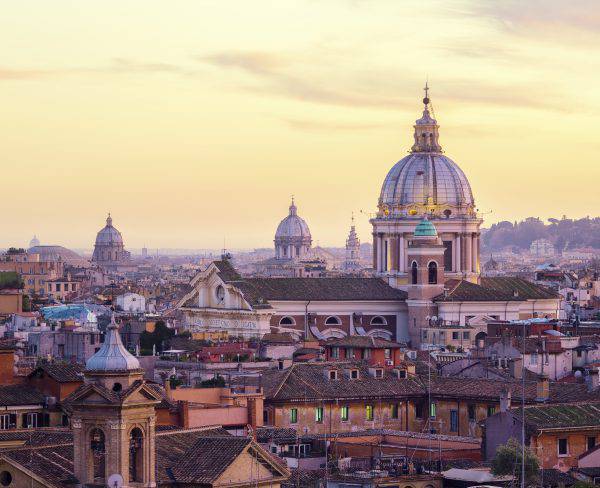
xmin=379 ymin=152 xmax=474 ymax=206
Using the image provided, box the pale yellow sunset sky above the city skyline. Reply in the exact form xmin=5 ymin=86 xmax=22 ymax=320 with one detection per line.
xmin=0 ymin=0 xmax=600 ymax=248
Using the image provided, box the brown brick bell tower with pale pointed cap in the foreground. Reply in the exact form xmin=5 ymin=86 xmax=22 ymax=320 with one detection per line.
xmin=70 ymin=314 xmax=160 ymax=488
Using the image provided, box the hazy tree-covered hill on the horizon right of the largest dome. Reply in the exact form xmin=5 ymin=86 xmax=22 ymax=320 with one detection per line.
xmin=481 ymin=216 xmax=600 ymax=251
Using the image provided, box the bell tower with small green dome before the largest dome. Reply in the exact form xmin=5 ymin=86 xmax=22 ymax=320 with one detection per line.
xmin=406 ymin=217 xmax=445 ymax=347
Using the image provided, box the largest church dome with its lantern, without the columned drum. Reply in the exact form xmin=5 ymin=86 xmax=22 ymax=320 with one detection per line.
xmin=379 ymin=90 xmax=475 ymax=217
